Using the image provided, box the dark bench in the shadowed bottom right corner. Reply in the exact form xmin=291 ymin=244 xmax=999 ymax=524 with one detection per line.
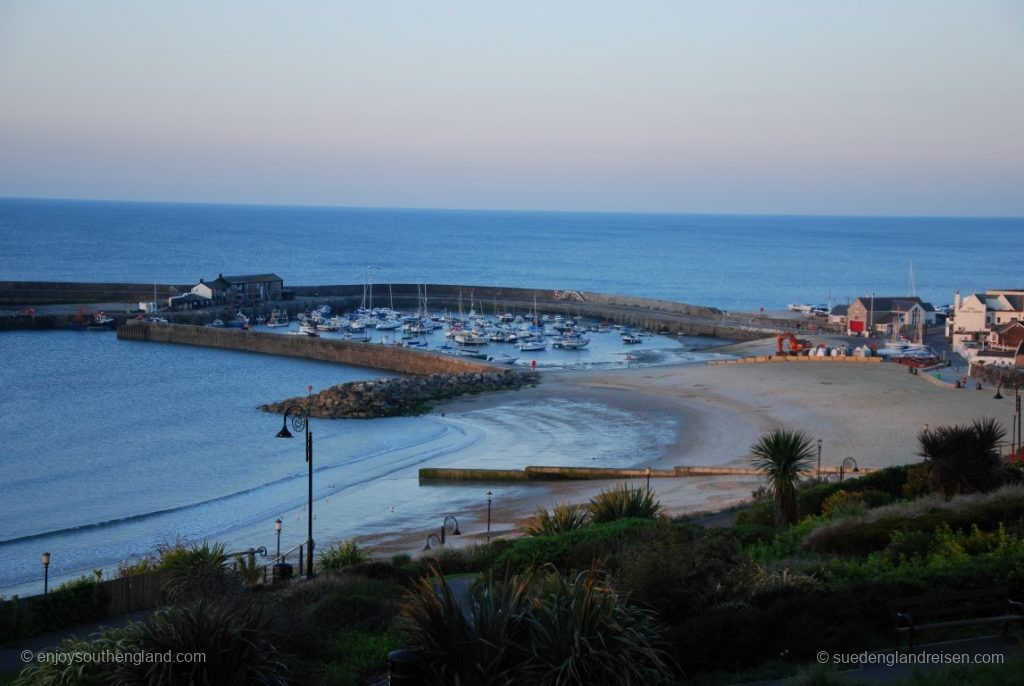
xmin=889 ymin=588 xmax=1024 ymax=650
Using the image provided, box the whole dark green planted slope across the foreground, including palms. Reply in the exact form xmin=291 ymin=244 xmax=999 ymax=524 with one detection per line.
xmin=8 ymin=423 xmax=1024 ymax=685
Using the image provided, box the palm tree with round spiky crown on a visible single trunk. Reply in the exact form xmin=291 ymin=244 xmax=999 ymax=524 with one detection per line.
xmin=751 ymin=429 xmax=814 ymax=526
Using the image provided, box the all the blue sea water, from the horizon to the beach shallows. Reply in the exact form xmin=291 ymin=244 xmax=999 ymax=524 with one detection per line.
xmin=0 ymin=199 xmax=1024 ymax=596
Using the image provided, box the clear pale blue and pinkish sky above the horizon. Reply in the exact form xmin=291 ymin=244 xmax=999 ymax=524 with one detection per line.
xmin=0 ymin=0 xmax=1024 ymax=216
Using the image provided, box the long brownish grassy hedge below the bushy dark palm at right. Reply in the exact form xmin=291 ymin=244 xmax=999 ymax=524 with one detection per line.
xmin=804 ymin=486 xmax=1024 ymax=555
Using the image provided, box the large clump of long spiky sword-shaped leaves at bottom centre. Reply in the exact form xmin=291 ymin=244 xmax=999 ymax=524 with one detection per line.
xmin=400 ymin=569 xmax=669 ymax=685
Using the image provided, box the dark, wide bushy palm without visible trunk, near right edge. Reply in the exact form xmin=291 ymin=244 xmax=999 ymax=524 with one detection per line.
xmin=918 ymin=419 xmax=1006 ymax=499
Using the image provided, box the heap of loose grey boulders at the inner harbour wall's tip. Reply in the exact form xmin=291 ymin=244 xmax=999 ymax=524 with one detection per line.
xmin=260 ymin=370 xmax=541 ymax=419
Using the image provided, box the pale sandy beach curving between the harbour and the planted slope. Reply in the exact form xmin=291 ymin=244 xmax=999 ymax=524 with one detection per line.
xmin=365 ymin=339 xmax=1014 ymax=553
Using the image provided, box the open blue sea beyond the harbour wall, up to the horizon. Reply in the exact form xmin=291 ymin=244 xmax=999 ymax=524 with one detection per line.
xmin=0 ymin=200 xmax=1024 ymax=311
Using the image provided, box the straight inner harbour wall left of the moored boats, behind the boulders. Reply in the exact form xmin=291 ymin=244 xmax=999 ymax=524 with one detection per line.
xmin=118 ymin=321 xmax=501 ymax=376
